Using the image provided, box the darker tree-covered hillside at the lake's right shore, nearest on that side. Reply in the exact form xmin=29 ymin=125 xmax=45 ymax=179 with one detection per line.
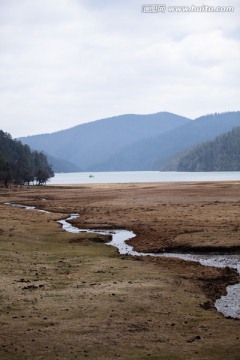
xmin=174 ymin=127 xmax=240 ymax=171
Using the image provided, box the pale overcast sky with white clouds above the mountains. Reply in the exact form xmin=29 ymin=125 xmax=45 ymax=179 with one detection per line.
xmin=0 ymin=0 xmax=240 ymax=137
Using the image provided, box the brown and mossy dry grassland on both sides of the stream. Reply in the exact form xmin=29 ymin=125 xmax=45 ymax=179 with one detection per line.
xmin=0 ymin=182 xmax=240 ymax=360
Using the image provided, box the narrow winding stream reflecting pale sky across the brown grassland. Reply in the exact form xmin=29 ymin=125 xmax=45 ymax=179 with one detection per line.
xmin=5 ymin=203 xmax=240 ymax=319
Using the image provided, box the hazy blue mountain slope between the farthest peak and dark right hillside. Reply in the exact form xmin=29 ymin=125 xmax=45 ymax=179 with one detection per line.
xmin=96 ymin=111 xmax=240 ymax=171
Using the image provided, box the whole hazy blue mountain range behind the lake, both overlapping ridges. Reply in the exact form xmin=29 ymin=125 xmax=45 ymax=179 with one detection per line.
xmin=21 ymin=111 xmax=240 ymax=171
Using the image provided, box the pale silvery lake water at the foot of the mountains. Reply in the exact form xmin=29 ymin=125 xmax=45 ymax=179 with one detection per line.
xmin=48 ymin=171 xmax=240 ymax=185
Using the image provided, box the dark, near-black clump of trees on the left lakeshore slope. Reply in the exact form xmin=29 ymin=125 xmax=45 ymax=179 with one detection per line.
xmin=0 ymin=130 xmax=54 ymax=186
